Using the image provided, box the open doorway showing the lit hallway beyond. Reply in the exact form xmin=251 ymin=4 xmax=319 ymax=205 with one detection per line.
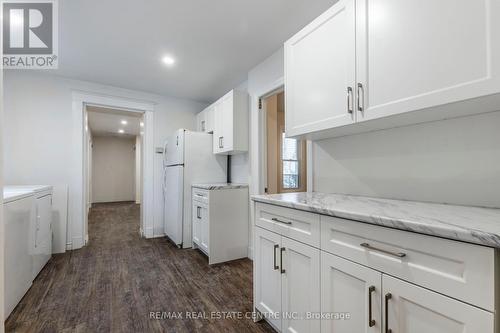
xmin=84 ymin=105 xmax=144 ymax=243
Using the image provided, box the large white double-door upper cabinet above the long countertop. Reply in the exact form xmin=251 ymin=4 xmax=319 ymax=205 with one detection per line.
xmin=285 ymin=0 xmax=500 ymax=139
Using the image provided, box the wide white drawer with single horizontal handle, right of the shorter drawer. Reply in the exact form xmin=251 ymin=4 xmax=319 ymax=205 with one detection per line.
xmin=321 ymin=216 xmax=495 ymax=311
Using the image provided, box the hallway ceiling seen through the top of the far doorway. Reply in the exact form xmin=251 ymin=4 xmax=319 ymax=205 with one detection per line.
xmin=87 ymin=106 xmax=142 ymax=137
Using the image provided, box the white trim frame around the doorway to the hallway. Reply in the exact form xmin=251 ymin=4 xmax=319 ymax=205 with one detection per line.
xmin=71 ymin=91 xmax=155 ymax=250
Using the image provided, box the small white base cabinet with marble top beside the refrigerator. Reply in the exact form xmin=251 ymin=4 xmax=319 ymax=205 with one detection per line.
xmin=192 ymin=184 xmax=248 ymax=265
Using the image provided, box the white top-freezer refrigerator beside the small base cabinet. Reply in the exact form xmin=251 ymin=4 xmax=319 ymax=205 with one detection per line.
xmin=163 ymin=129 xmax=227 ymax=248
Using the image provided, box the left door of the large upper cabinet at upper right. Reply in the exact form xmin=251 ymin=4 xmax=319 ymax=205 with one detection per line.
xmin=285 ymin=0 xmax=356 ymax=136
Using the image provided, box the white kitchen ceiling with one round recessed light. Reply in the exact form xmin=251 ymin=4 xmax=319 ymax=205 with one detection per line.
xmin=57 ymin=0 xmax=337 ymax=102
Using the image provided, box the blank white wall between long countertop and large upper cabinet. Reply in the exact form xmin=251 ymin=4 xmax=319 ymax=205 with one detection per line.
xmin=313 ymin=112 xmax=500 ymax=208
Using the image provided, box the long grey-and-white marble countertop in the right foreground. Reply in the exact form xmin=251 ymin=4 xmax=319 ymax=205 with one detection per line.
xmin=252 ymin=193 xmax=500 ymax=248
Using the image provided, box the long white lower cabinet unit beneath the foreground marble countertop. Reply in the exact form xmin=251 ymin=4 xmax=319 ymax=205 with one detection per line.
xmin=254 ymin=203 xmax=498 ymax=333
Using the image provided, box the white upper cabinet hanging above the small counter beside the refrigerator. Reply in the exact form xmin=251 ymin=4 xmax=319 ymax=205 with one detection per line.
xmin=213 ymin=90 xmax=248 ymax=155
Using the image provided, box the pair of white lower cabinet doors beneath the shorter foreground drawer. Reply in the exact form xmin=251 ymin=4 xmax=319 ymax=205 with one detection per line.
xmin=254 ymin=228 xmax=320 ymax=333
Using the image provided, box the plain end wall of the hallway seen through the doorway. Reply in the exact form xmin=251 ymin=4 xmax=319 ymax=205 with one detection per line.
xmin=92 ymin=136 xmax=136 ymax=203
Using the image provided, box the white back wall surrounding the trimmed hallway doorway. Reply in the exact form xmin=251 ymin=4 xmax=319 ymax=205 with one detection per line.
xmin=3 ymin=71 xmax=204 ymax=249
